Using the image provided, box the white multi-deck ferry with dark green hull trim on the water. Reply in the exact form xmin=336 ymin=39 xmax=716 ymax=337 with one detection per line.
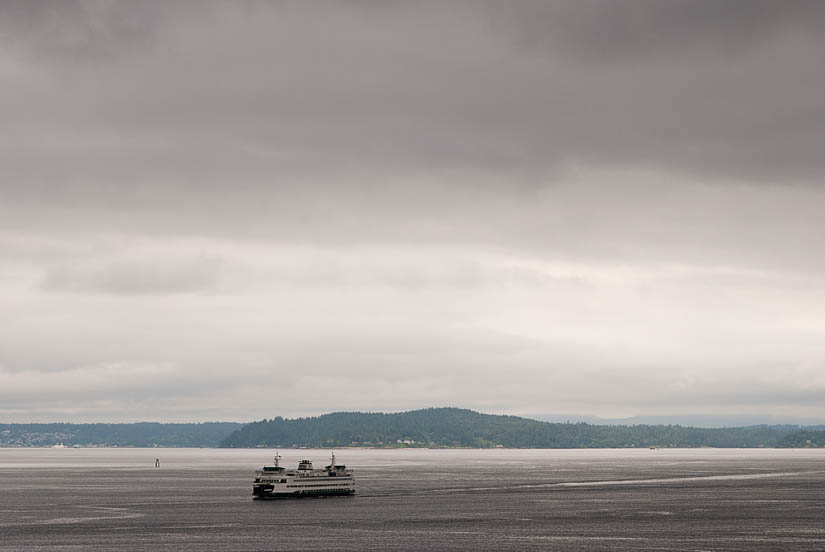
xmin=252 ymin=454 xmax=355 ymax=499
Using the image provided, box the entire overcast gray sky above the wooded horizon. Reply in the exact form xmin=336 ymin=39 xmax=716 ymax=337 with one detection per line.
xmin=0 ymin=0 xmax=825 ymax=422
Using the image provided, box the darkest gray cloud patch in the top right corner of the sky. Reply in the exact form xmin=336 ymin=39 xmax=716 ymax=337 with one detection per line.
xmin=491 ymin=0 xmax=825 ymax=60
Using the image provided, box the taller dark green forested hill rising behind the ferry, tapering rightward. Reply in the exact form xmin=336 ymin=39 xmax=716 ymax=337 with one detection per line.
xmin=221 ymin=408 xmax=816 ymax=448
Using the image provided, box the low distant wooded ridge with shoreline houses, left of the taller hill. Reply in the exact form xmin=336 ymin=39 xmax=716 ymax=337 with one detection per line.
xmin=0 ymin=422 xmax=243 ymax=447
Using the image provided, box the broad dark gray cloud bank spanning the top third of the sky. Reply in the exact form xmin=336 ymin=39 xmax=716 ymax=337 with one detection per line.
xmin=3 ymin=2 xmax=825 ymax=192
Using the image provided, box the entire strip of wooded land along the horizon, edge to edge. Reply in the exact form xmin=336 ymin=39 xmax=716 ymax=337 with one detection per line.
xmin=6 ymin=414 xmax=825 ymax=448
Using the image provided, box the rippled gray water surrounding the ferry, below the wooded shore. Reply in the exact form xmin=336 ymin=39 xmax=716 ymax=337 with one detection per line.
xmin=0 ymin=449 xmax=825 ymax=551
